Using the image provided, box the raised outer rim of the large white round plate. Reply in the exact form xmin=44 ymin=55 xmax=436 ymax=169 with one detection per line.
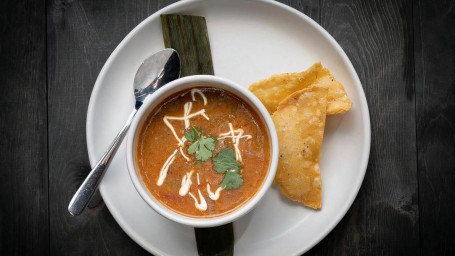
xmin=86 ymin=0 xmax=371 ymax=255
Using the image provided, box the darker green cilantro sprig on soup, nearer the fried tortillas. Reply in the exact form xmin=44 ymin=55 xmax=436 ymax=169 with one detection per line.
xmin=213 ymin=148 xmax=243 ymax=189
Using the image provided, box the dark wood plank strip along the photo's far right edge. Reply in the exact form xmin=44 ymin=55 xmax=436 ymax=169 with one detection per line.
xmin=414 ymin=1 xmax=455 ymax=255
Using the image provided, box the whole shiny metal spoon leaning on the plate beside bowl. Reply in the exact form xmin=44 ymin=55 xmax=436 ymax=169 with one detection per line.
xmin=68 ymin=49 xmax=180 ymax=216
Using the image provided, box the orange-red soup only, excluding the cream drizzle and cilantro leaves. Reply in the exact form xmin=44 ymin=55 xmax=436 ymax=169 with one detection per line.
xmin=136 ymin=88 xmax=270 ymax=217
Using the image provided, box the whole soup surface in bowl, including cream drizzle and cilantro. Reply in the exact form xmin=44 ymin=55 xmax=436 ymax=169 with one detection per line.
xmin=136 ymin=88 xmax=270 ymax=217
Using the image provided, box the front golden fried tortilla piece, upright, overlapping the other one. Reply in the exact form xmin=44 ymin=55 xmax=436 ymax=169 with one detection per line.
xmin=272 ymin=86 xmax=328 ymax=209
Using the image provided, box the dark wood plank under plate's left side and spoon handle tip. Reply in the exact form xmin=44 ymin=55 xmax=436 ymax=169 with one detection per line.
xmin=47 ymin=0 xmax=174 ymax=255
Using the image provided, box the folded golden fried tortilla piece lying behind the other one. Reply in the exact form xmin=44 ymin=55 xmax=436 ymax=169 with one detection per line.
xmin=249 ymin=62 xmax=352 ymax=115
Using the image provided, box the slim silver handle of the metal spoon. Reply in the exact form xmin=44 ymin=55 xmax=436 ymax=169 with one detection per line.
xmin=68 ymin=109 xmax=137 ymax=216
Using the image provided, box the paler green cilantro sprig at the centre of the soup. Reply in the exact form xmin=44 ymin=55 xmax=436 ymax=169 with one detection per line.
xmin=184 ymin=127 xmax=216 ymax=162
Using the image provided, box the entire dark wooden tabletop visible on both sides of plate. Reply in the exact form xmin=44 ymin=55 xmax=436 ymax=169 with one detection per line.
xmin=0 ymin=0 xmax=455 ymax=255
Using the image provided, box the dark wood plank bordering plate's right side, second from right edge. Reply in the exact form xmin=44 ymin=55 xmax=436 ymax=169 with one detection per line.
xmin=309 ymin=0 xmax=419 ymax=255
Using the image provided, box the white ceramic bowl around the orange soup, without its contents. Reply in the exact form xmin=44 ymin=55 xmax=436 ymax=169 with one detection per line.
xmin=126 ymin=75 xmax=279 ymax=227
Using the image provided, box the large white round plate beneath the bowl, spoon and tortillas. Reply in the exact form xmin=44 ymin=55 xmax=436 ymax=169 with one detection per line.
xmin=87 ymin=0 xmax=370 ymax=255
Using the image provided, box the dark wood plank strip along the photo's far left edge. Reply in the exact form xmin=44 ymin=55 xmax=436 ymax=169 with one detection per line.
xmin=0 ymin=0 xmax=49 ymax=255
